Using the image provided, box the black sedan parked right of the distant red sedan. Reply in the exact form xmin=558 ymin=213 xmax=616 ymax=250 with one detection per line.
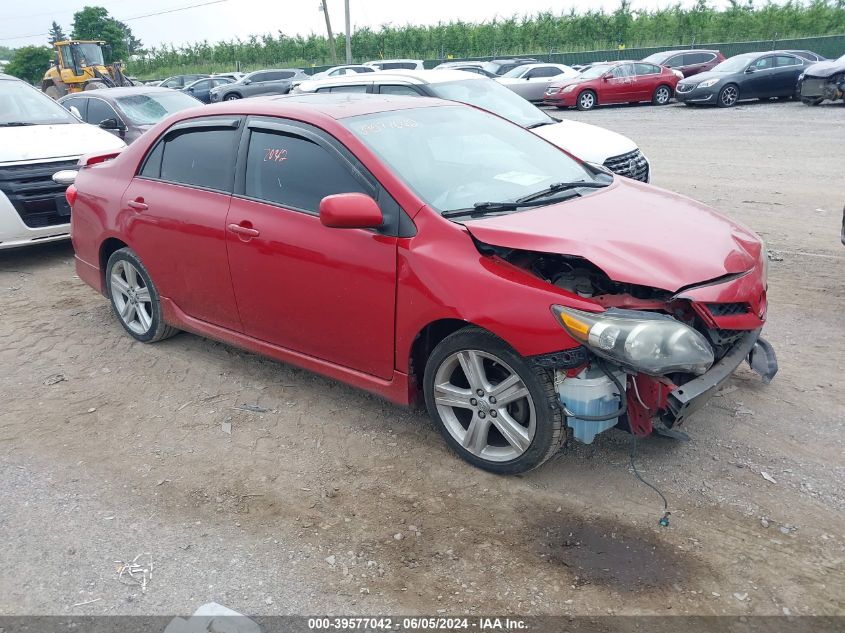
xmin=675 ymin=51 xmax=811 ymax=108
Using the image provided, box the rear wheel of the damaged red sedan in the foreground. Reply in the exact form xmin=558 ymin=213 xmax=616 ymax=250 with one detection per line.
xmin=106 ymin=248 xmax=179 ymax=343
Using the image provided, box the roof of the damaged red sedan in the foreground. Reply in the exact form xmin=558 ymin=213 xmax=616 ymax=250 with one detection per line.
xmin=186 ymin=93 xmax=458 ymax=119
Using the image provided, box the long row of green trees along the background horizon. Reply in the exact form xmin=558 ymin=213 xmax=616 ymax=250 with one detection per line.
xmin=7 ymin=0 xmax=845 ymax=82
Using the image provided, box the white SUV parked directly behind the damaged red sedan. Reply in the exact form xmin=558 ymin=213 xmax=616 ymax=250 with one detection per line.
xmin=295 ymin=70 xmax=651 ymax=182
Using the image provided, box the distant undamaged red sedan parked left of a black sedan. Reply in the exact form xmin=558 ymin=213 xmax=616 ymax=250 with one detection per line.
xmin=543 ymin=62 xmax=680 ymax=110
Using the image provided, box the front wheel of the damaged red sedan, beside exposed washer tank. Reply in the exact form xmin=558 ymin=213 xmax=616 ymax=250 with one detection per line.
xmin=423 ymin=327 xmax=566 ymax=475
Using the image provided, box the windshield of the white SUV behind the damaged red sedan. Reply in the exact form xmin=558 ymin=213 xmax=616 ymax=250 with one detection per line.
xmin=429 ymin=79 xmax=555 ymax=127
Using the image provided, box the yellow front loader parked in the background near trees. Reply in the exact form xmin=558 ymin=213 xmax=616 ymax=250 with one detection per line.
xmin=41 ymin=40 xmax=135 ymax=99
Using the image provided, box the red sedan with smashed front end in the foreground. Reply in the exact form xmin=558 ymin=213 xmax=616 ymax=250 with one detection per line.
xmin=67 ymin=94 xmax=775 ymax=473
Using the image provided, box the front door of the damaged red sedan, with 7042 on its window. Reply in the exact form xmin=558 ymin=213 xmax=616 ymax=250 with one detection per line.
xmin=226 ymin=119 xmax=399 ymax=378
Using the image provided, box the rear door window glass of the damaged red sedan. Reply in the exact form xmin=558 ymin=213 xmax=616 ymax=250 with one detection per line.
xmin=140 ymin=122 xmax=238 ymax=193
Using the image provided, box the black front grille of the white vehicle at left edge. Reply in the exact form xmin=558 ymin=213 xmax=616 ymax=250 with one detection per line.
xmin=0 ymin=160 xmax=76 ymax=229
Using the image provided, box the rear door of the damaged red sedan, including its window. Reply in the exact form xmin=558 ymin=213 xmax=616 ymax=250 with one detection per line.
xmin=121 ymin=117 xmax=241 ymax=330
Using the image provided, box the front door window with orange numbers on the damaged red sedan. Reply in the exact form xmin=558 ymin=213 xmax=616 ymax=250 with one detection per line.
xmin=244 ymin=130 xmax=372 ymax=213
